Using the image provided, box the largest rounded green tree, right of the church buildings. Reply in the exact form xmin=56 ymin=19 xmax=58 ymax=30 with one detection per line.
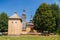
xmin=33 ymin=3 xmax=56 ymax=32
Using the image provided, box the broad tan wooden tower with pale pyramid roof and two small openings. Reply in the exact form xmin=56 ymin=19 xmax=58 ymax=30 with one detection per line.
xmin=8 ymin=12 xmax=22 ymax=35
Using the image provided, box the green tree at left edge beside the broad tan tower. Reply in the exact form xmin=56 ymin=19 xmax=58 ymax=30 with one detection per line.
xmin=0 ymin=12 xmax=8 ymax=32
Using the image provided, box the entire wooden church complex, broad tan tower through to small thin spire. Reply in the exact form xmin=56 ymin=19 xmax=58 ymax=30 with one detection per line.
xmin=8 ymin=10 xmax=34 ymax=35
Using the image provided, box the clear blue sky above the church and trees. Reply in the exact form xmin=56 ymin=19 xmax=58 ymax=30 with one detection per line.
xmin=0 ymin=0 xmax=60 ymax=22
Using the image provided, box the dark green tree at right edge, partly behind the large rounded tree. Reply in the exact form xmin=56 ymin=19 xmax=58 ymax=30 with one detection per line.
xmin=51 ymin=3 xmax=59 ymax=31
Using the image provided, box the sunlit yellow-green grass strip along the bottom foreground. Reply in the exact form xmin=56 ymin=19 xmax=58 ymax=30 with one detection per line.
xmin=0 ymin=35 xmax=60 ymax=40
